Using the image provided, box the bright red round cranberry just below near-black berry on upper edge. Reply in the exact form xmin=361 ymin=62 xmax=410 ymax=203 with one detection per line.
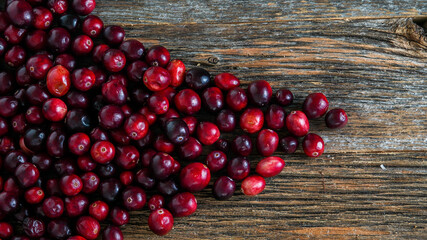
xmin=174 ymin=89 xmax=202 ymax=115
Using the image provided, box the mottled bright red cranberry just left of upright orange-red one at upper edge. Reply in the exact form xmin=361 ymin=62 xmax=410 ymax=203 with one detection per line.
xmin=143 ymin=66 xmax=172 ymax=92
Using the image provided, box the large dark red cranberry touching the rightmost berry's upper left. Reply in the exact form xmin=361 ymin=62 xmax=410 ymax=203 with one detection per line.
xmin=302 ymin=93 xmax=329 ymax=119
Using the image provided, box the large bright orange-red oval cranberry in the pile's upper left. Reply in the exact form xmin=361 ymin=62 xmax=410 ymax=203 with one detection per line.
xmin=46 ymin=65 xmax=71 ymax=97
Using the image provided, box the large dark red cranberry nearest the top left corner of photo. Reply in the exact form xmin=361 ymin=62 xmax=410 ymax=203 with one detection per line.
xmin=6 ymin=0 xmax=34 ymax=27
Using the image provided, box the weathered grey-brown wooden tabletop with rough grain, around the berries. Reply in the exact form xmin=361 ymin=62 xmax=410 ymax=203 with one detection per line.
xmin=96 ymin=0 xmax=427 ymax=239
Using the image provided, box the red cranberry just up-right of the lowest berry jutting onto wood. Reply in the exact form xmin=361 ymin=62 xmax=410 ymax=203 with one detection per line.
xmin=168 ymin=192 xmax=197 ymax=217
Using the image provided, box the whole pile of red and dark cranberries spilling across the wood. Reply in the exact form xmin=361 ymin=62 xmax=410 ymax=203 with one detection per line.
xmin=0 ymin=0 xmax=347 ymax=240
